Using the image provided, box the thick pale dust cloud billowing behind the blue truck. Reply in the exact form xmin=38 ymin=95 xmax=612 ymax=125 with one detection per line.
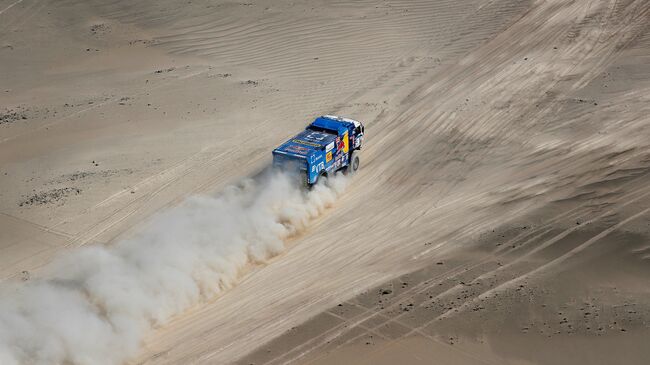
xmin=0 ymin=173 xmax=346 ymax=365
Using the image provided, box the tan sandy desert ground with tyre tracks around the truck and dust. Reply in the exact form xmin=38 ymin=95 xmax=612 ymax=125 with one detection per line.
xmin=0 ymin=0 xmax=650 ymax=364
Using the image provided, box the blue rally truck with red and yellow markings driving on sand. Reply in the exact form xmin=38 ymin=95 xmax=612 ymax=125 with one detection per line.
xmin=273 ymin=115 xmax=364 ymax=187
